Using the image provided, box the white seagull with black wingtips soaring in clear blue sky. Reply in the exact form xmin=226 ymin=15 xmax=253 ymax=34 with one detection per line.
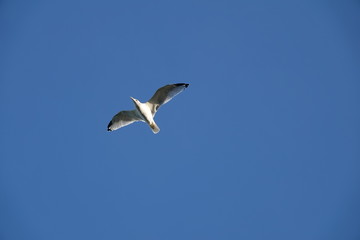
xmin=107 ymin=83 xmax=189 ymax=134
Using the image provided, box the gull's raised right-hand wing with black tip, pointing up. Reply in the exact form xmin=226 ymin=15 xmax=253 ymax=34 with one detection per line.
xmin=146 ymin=83 xmax=189 ymax=115
